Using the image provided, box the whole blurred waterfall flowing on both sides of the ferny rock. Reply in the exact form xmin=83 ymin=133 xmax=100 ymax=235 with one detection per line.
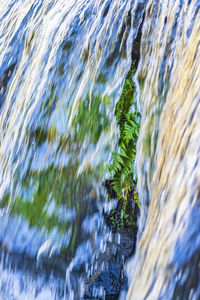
xmin=0 ymin=0 xmax=200 ymax=300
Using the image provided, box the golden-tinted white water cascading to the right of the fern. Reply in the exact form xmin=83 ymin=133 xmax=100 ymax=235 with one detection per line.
xmin=127 ymin=0 xmax=200 ymax=300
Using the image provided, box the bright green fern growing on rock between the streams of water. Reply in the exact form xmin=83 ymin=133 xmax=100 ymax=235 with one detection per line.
xmin=108 ymin=63 xmax=140 ymax=212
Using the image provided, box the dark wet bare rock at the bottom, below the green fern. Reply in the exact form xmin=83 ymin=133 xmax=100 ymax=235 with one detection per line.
xmin=84 ymin=227 xmax=137 ymax=300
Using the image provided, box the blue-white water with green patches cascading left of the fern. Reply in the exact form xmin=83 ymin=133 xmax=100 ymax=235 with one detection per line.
xmin=0 ymin=0 xmax=145 ymax=300
